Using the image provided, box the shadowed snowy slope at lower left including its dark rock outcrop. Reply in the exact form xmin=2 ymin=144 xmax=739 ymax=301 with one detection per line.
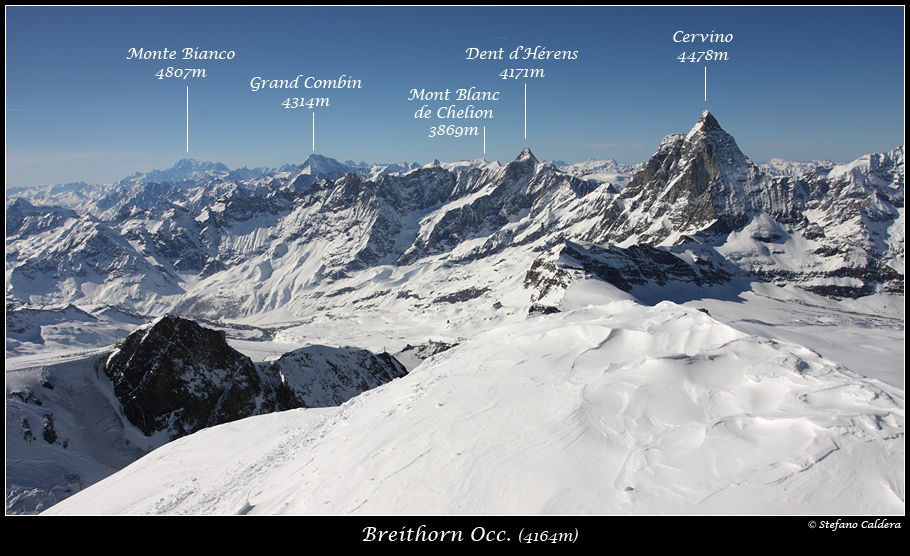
xmin=6 ymin=309 xmax=407 ymax=513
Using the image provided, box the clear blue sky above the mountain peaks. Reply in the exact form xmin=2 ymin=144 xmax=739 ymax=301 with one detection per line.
xmin=6 ymin=6 xmax=905 ymax=186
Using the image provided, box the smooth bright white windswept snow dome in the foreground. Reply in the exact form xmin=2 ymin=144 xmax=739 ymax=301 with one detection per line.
xmin=46 ymin=296 xmax=905 ymax=515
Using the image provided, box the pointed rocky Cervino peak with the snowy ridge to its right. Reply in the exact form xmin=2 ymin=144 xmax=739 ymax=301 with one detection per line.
xmin=598 ymin=111 xmax=904 ymax=297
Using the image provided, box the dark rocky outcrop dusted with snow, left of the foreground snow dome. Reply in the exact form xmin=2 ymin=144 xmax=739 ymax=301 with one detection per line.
xmin=104 ymin=315 xmax=407 ymax=440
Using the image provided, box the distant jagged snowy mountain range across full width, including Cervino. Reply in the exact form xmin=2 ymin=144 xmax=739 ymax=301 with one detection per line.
xmin=6 ymin=112 xmax=904 ymax=319
